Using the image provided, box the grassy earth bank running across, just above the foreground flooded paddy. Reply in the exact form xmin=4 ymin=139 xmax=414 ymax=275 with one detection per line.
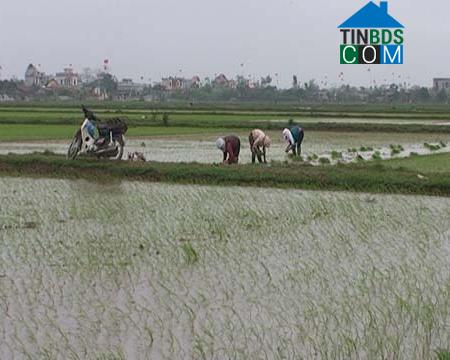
xmin=0 ymin=154 xmax=450 ymax=196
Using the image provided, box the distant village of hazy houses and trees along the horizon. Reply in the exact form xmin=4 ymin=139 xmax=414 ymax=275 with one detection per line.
xmin=0 ymin=60 xmax=450 ymax=103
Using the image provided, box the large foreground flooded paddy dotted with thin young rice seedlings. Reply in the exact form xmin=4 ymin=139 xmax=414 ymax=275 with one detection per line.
xmin=0 ymin=178 xmax=450 ymax=359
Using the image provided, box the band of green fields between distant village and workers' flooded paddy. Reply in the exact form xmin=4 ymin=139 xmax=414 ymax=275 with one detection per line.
xmin=0 ymin=102 xmax=450 ymax=141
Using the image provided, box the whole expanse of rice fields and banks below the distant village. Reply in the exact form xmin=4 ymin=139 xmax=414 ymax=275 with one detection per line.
xmin=0 ymin=102 xmax=450 ymax=360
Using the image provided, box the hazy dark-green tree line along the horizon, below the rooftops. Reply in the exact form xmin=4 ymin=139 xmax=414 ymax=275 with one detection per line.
xmin=0 ymin=74 xmax=450 ymax=104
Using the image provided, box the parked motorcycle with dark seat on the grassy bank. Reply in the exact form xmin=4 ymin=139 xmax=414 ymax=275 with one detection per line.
xmin=67 ymin=106 xmax=128 ymax=160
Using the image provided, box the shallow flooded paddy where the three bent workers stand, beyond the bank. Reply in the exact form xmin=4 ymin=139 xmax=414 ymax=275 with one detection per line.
xmin=0 ymin=131 xmax=450 ymax=163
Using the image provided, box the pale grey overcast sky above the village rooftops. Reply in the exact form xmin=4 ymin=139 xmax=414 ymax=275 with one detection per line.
xmin=0 ymin=0 xmax=450 ymax=86
